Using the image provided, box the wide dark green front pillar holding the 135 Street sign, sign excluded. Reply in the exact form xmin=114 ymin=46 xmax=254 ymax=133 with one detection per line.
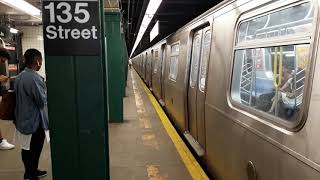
xmin=44 ymin=0 xmax=110 ymax=180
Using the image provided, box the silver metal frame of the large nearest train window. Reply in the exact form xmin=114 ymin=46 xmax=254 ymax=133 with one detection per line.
xmin=227 ymin=1 xmax=319 ymax=131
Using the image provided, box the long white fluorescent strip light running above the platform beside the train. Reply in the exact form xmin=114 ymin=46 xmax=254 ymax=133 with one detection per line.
xmin=130 ymin=0 xmax=162 ymax=57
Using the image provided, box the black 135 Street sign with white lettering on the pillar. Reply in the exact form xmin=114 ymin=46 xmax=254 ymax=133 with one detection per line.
xmin=42 ymin=0 xmax=101 ymax=56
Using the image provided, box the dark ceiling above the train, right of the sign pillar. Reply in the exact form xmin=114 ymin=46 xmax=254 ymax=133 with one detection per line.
xmin=121 ymin=0 xmax=223 ymax=55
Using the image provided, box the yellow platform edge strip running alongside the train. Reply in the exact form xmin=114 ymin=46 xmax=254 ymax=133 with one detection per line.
xmin=139 ymin=74 xmax=209 ymax=180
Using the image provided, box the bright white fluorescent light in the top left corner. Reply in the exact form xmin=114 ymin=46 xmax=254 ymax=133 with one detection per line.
xmin=0 ymin=0 xmax=41 ymax=16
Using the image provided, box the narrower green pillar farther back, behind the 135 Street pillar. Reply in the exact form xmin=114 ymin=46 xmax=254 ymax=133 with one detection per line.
xmin=105 ymin=10 xmax=125 ymax=123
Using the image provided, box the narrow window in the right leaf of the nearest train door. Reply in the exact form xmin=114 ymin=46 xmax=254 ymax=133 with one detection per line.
xmin=199 ymin=31 xmax=211 ymax=92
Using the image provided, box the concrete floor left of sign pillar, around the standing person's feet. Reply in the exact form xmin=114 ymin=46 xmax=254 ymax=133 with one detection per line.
xmin=0 ymin=120 xmax=52 ymax=180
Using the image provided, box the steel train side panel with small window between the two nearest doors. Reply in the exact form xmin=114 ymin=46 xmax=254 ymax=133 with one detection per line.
xmin=163 ymin=30 xmax=188 ymax=132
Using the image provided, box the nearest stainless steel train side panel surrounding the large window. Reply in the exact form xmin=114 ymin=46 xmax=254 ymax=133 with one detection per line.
xmin=205 ymin=1 xmax=320 ymax=180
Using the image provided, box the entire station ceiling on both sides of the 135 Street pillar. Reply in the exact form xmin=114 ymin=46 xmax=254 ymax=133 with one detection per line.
xmin=0 ymin=0 xmax=223 ymax=54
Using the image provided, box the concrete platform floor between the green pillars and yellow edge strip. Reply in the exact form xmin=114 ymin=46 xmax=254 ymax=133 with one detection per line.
xmin=109 ymin=71 xmax=192 ymax=180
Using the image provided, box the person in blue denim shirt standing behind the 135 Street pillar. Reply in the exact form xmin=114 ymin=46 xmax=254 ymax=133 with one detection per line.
xmin=14 ymin=49 xmax=49 ymax=180
